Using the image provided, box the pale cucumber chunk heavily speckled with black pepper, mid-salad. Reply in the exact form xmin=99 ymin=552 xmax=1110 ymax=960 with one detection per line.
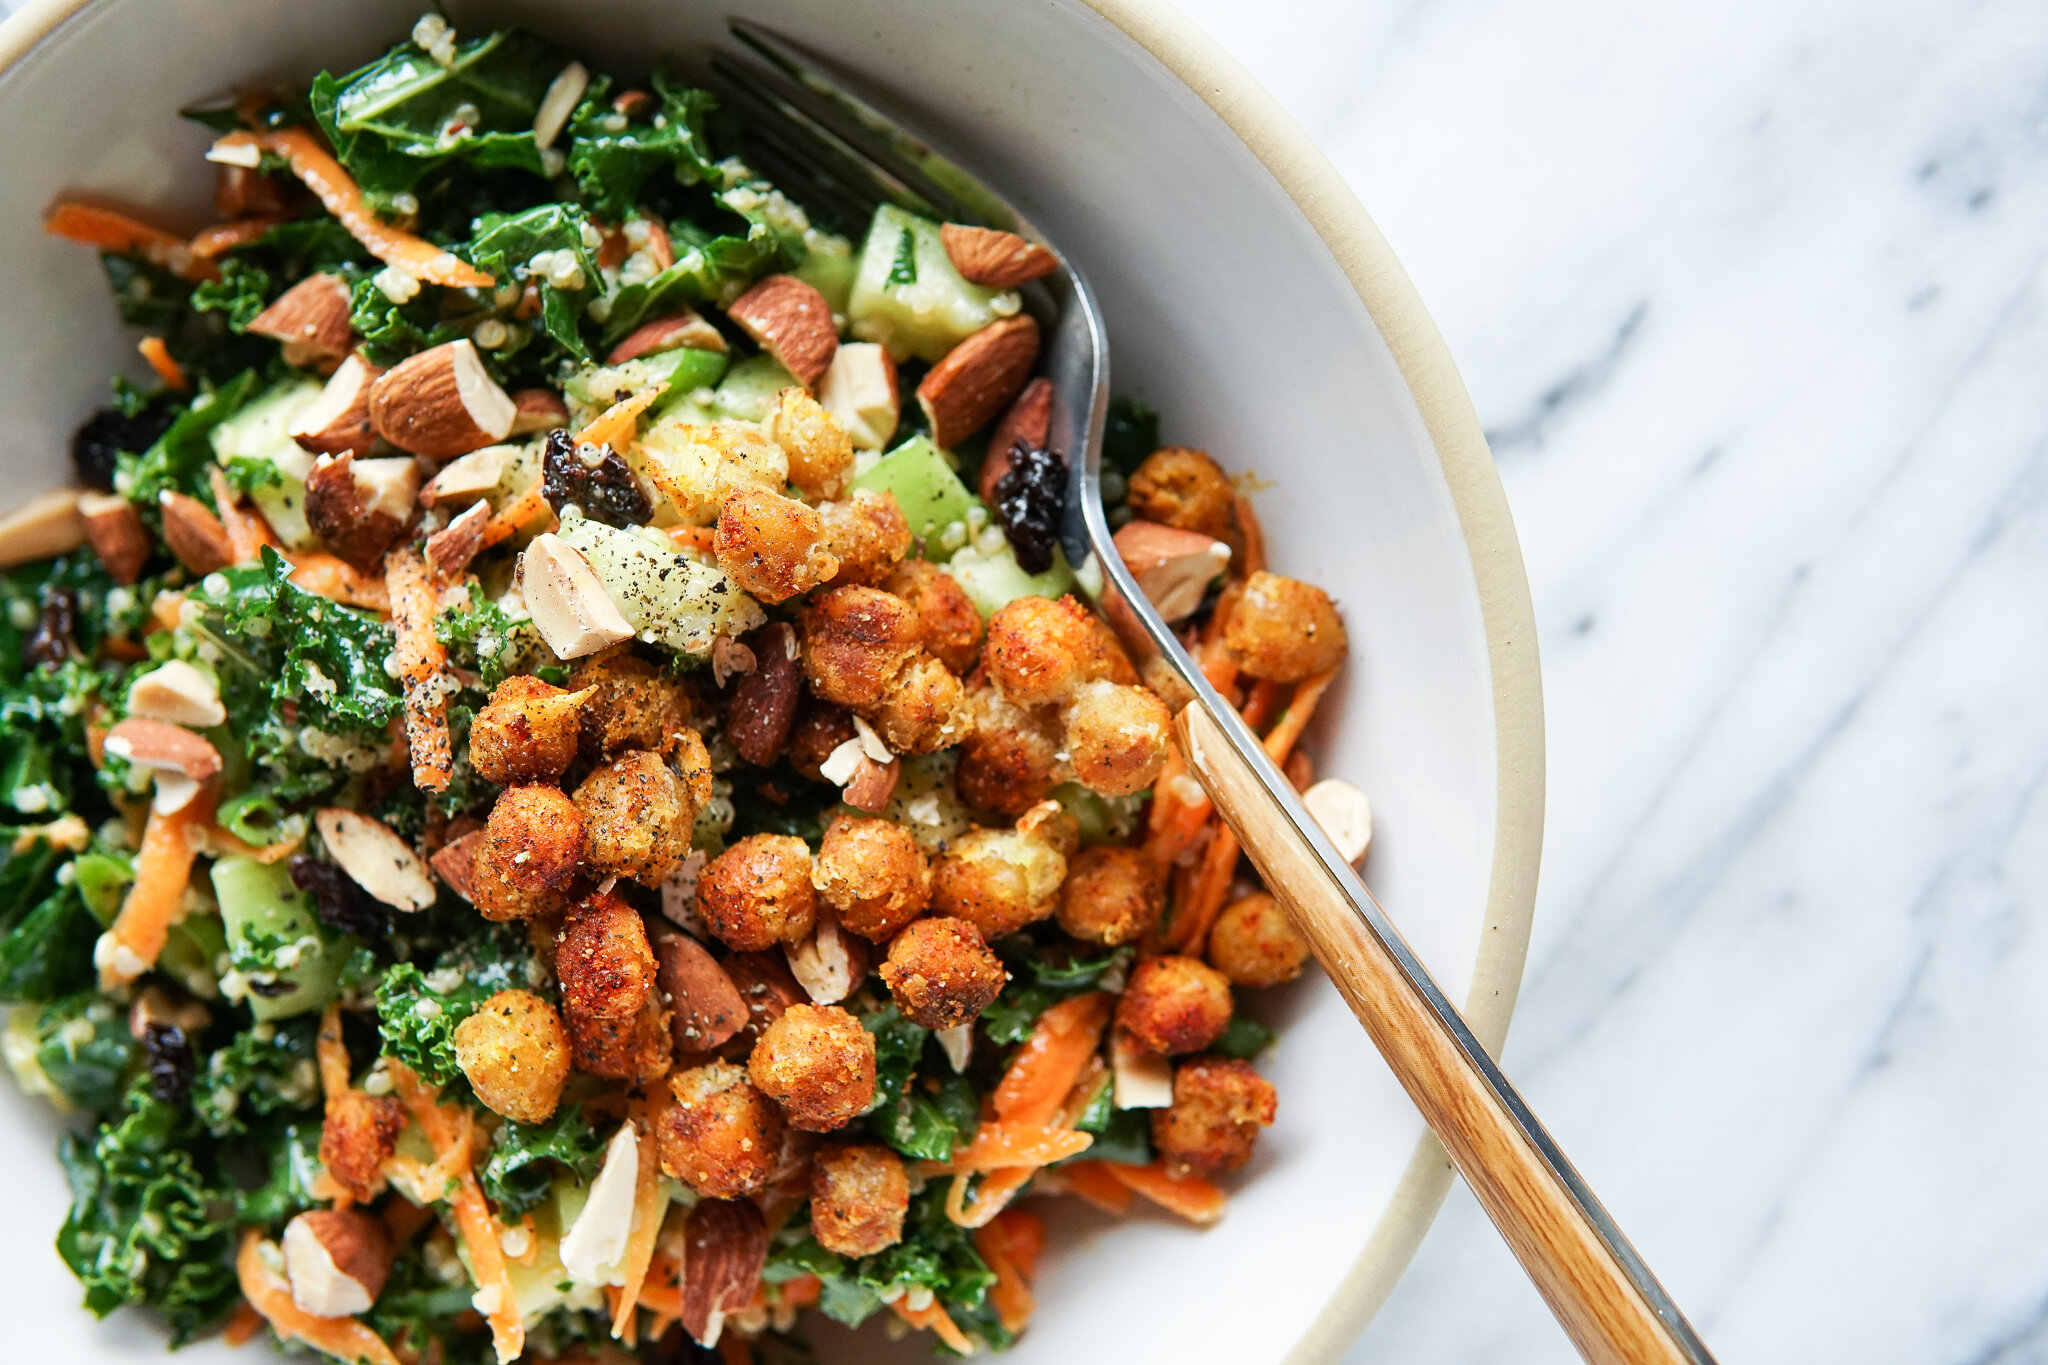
xmin=557 ymin=518 xmax=768 ymax=657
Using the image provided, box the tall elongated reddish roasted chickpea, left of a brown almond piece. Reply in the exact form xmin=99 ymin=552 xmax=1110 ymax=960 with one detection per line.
xmin=555 ymin=894 xmax=670 ymax=1081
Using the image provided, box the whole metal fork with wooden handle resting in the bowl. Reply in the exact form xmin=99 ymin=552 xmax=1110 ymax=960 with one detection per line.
xmin=711 ymin=20 xmax=1712 ymax=1365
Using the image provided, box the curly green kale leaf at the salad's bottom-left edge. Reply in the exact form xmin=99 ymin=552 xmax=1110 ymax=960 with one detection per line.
xmin=57 ymin=1087 xmax=236 ymax=1345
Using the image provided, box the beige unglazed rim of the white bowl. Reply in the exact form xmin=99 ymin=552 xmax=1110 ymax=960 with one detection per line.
xmin=0 ymin=0 xmax=1544 ymax=1365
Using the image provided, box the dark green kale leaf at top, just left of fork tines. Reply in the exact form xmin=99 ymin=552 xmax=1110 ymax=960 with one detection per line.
xmin=569 ymin=72 xmax=719 ymax=221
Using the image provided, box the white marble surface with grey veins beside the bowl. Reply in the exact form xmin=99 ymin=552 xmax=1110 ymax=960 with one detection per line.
xmin=1184 ymin=0 xmax=2048 ymax=1365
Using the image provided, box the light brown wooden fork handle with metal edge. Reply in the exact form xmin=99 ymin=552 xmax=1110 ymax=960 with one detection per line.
xmin=1176 ymin=704 xmax=1712 ymax=1365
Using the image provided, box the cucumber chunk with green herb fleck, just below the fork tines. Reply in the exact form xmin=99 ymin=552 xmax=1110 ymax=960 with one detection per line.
xmin=846 ymin=205 xmax=1018 ymax=360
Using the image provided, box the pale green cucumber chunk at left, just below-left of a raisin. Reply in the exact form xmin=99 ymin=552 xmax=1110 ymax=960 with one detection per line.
xmin=213 ymin=857 xmax=352 ymax=1019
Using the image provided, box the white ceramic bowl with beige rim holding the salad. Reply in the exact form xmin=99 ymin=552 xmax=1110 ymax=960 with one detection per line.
xmin=0 ymin=0 xmax=1542 ymax=1365
